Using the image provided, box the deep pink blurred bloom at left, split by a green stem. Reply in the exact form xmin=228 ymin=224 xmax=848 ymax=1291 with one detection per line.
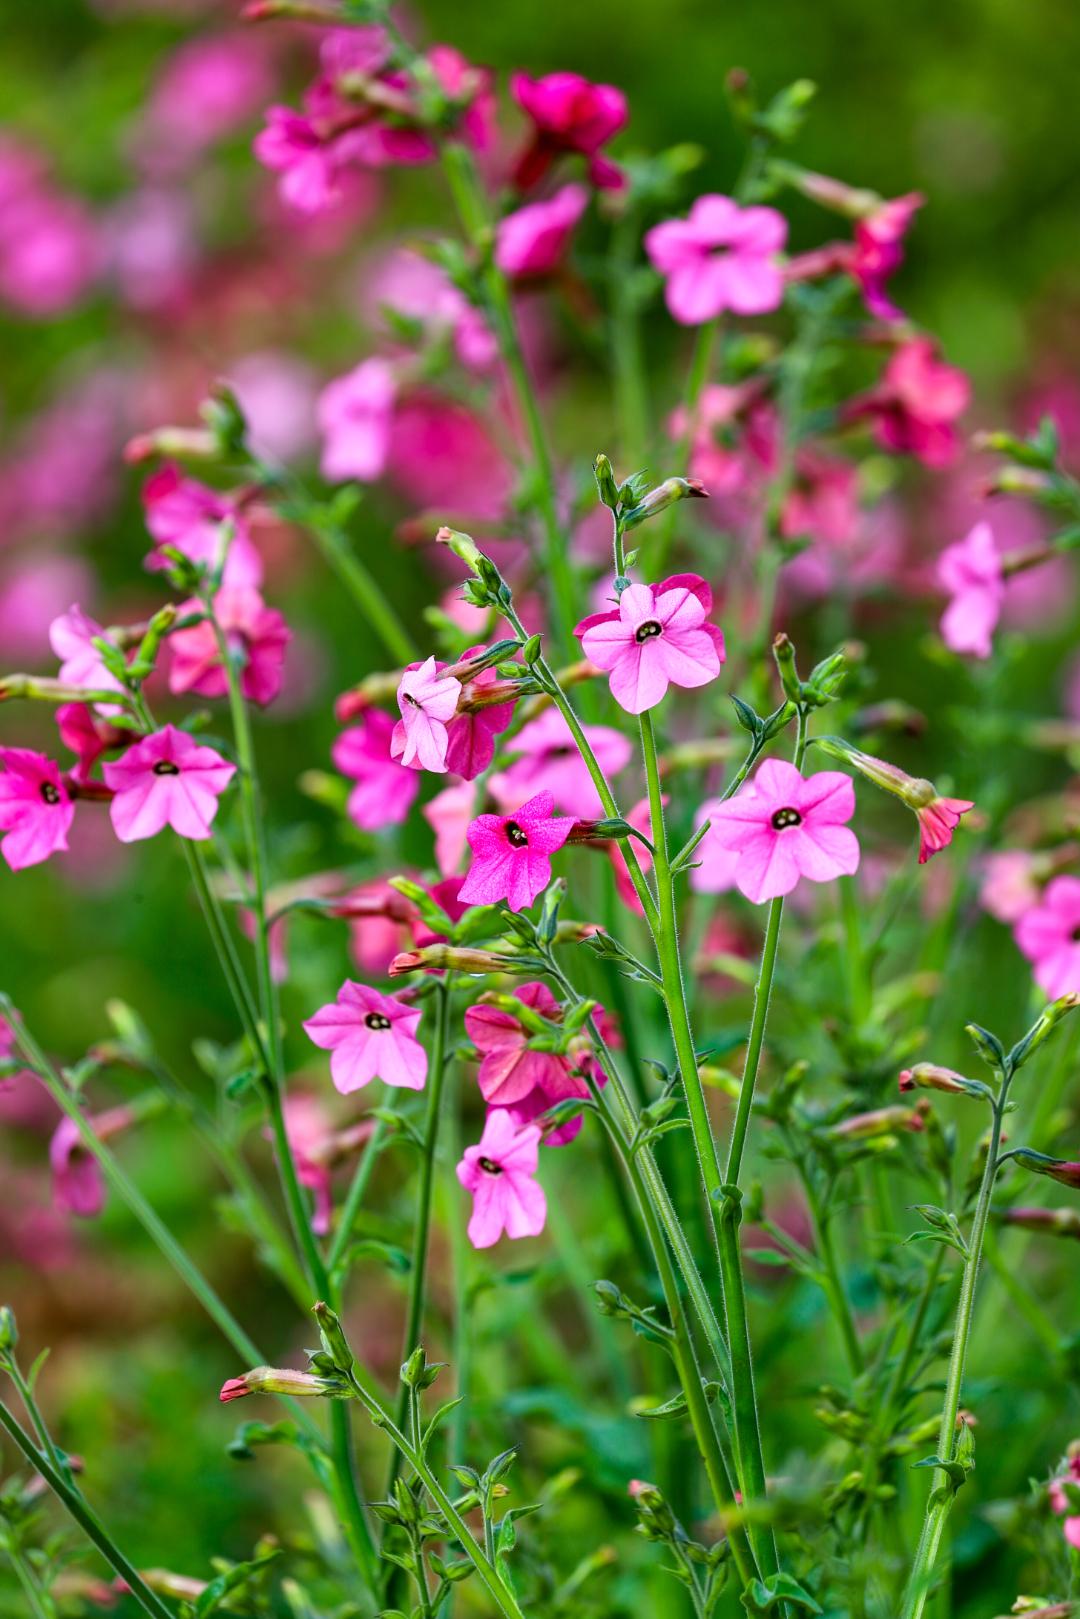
xmin=168 ymin=584 xmax=291 ymax=708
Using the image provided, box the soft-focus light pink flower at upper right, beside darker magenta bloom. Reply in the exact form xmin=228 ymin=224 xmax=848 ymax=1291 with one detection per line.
xmin=644 ymin=194 xmax=787 ymax=325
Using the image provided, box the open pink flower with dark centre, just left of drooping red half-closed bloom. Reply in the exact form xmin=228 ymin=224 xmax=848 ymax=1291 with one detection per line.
xmin=709 ymin=759 xmax=858 ymax=905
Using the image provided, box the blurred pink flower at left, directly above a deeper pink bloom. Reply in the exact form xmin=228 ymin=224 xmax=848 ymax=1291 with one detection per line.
xmin=142 ymin=461 xmax=262 ymax=589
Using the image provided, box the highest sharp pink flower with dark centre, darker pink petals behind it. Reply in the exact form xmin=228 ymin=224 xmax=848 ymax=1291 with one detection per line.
xmin=573 ymin=573 xmax=724 ymax=714
